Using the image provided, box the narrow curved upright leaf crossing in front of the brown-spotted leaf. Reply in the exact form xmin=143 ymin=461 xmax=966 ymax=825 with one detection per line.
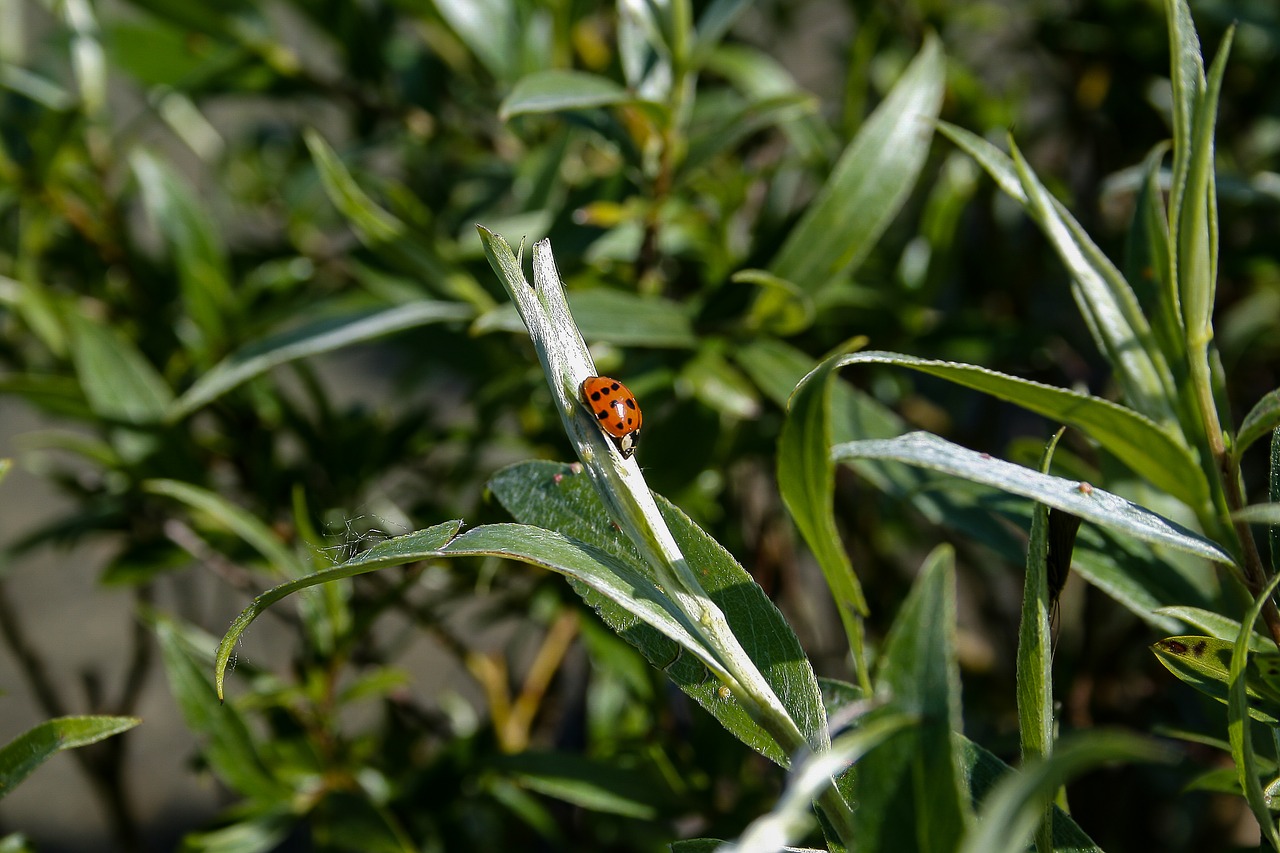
xmin=1226 ymin=574 xmax=1280 ymax=850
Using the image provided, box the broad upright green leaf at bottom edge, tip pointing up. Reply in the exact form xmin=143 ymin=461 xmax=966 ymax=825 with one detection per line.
xmin=841 ymin=546 xmax=970 ymax=853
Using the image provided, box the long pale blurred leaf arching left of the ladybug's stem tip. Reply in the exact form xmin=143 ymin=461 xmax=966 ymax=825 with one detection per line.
xmin=169 ymin=300 xmax=475 ymax=421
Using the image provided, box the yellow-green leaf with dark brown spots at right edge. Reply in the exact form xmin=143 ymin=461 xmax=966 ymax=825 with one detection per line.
xmin=1151 ymin=635 xmax=1280 ymax=725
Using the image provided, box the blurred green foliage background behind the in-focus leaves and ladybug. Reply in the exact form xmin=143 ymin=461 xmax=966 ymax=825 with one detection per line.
xmin=0 ymin=0 xmax=1280 ymax=850
